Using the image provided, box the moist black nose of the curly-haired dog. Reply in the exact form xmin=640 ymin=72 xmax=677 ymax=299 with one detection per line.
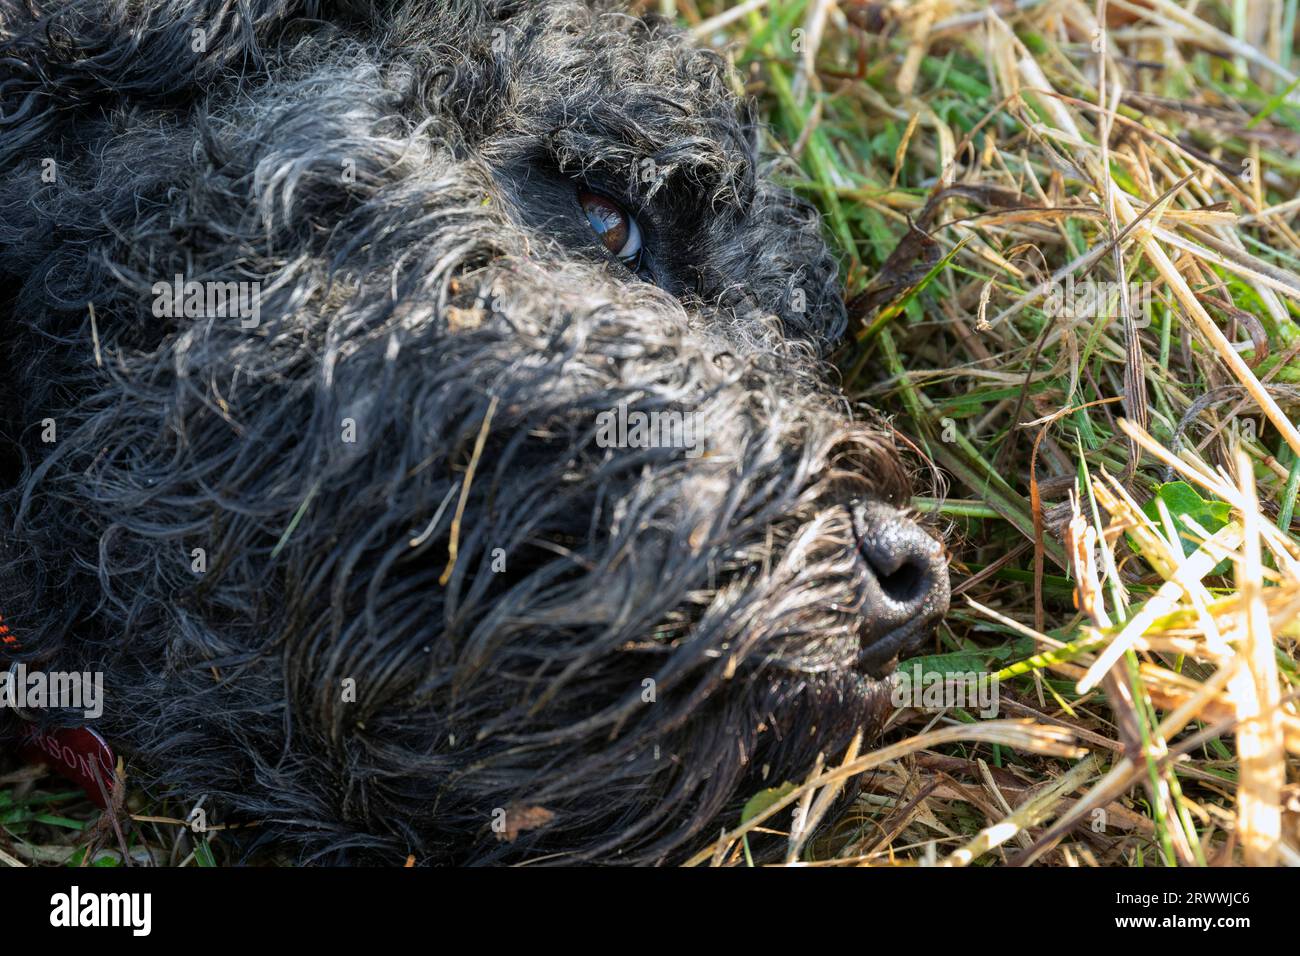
xmin=854 ymin=502 xmax=948 ymax=671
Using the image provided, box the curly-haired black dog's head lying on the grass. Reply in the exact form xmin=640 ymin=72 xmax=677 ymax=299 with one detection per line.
xmin=0 ymin=0 xmax=948 ymax=862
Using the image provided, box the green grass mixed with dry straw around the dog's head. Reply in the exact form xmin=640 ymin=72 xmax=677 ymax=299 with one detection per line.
xmin=0 ymin=0 xmax=1300 ymax=866
